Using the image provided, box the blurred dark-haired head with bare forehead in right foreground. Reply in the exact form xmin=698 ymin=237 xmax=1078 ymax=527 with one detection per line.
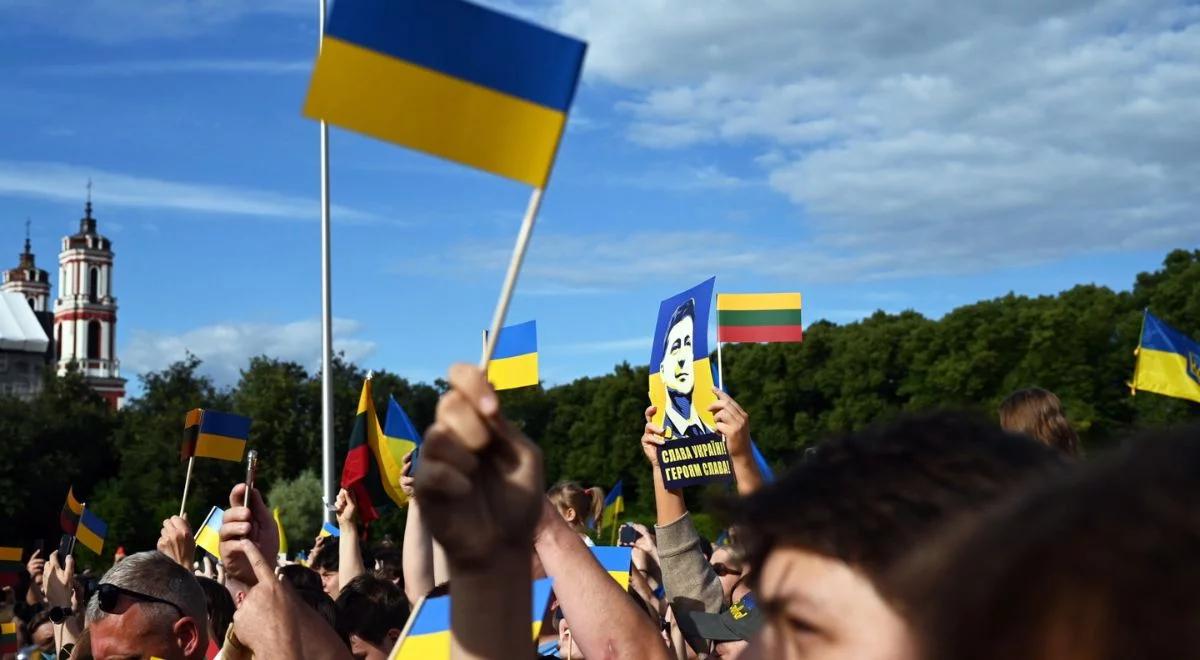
xmin=739 ymin=414 xmax=1063 ymax=659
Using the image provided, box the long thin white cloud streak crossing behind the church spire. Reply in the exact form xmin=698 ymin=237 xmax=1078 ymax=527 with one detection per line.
xmin=0 ymin=161 xmax=379 ymax=223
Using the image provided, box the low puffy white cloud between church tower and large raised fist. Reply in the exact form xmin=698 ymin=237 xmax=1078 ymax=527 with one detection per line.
xmin=121 ymin=318 xmax=376 ymax=386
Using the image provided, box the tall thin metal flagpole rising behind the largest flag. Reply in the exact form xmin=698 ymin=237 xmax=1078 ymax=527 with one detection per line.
xmin=317 ymin=0 xmax=336 ymax=522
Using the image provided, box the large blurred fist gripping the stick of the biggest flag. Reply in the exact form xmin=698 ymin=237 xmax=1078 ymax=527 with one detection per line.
xmin=415 ymin=365 xmax=544 ymax=574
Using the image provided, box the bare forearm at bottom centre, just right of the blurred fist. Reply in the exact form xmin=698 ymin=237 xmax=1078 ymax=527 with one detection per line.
xmin=534 ymin=498 xmax=667 ymax=659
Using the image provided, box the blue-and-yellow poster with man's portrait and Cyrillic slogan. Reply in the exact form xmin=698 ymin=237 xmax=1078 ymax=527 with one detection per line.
xmin=649 ymin=277 xmax=733 ymax=488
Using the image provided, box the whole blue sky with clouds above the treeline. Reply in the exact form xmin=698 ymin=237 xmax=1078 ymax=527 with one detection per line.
xmin=0 ymin=0 xmax=1200 ymax=393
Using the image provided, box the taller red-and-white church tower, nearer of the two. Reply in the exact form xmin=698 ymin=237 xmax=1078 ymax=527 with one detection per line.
xmin=54 ymin=194 xmax=125 ymax=408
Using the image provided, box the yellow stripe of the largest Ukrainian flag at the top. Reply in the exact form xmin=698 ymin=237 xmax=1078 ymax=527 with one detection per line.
xmin=304 ymin=36 xmax=566 ymax=187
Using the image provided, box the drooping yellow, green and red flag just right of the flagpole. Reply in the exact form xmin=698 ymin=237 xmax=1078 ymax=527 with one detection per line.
xmin=342 ymin=378 xmax=407 ymax=524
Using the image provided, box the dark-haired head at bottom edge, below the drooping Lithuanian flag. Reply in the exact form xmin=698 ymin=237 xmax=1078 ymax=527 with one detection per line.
xmin=337 ymin=575 xmax=408 ymax=660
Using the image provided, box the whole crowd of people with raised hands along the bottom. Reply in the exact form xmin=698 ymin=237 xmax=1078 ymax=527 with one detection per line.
xmin=0 ymin=372 xmax=1200 ymax=660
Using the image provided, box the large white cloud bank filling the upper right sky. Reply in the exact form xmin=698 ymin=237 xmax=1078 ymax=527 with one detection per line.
xmin=551 ymin=0 xmax=1200 ymax=278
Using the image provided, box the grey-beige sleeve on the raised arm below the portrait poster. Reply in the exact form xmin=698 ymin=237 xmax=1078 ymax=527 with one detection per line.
xmin=654 ymin=514 xmax=725 ymax=614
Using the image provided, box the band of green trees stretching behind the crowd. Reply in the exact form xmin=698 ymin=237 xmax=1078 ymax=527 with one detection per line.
xmin=0 ymin=251 xmax=1200 ymax=563
